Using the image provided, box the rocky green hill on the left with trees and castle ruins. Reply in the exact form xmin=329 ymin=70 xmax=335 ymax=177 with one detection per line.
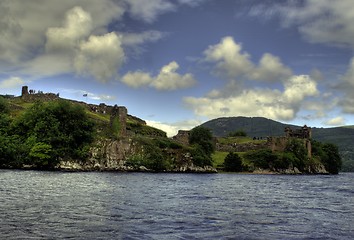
xmin=0 ymin=92 xmax=216 ymax=172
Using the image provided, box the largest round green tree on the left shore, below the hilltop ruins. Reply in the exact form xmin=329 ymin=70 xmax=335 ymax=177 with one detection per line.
xmin=13 ymin=101 xmax=94 ymax=168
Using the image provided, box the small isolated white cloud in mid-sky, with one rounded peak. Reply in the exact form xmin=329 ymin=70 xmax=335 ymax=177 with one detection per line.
xmin=121 ymin=61 xmax=196 ymax=90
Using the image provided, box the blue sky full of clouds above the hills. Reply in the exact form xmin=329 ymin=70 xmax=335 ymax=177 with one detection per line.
xmin=0 ymin=0 xmax=354 ymax=136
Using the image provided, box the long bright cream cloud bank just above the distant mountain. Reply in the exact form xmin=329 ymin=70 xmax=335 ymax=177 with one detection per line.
xmin=184 ymin=76 xmax=318 ymax=120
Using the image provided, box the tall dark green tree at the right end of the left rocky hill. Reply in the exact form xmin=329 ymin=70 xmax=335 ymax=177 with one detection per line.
xmin=189 ymin=126 xmax=214 ymax=166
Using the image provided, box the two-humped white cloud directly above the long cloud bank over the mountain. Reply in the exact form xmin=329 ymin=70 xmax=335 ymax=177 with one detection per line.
xmin=204 ymin=37 xmax=292 ymax=82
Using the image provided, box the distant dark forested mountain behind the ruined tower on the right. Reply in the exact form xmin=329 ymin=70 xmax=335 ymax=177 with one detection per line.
xmin=201 ymin=117 xmax=354 ymax=171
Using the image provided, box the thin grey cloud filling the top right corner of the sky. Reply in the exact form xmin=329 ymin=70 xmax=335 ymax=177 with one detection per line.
xmin=253 ymin=0 xmax=354 ymax=47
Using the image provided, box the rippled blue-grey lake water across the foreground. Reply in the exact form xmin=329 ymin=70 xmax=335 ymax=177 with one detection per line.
xmin=0 ymin=170 xmax=354 ymax=240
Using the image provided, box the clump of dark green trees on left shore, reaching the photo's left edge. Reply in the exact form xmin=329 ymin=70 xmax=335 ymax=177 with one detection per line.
xmin=0 ymin=98 xmax=94 ymax=169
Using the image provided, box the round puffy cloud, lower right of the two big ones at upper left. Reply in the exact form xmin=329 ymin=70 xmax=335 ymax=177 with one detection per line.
xmin=74 ymin=33 xmax=125 ymax=82
